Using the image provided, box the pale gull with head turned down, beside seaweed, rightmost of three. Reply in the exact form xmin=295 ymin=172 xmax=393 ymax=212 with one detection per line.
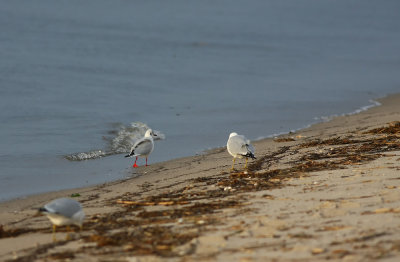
xmin=226 ymin=132 xmax=256 ymax=170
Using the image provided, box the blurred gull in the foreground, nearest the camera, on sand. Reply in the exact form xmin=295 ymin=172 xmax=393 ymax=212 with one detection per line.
xmin=39 ymin=198 xmax=85 ymax=241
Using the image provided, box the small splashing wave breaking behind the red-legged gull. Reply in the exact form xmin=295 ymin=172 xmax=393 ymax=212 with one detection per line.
xmin=65 ymin=122 xmax=165 ymax=161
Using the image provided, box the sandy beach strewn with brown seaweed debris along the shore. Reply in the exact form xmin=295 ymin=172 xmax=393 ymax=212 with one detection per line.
xmin=0 ymin=95 xmax=400 ymax=262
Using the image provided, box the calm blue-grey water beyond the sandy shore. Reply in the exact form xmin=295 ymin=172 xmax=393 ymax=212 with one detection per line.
xmin=0 ymin=0 xmax=400 ymax=200
